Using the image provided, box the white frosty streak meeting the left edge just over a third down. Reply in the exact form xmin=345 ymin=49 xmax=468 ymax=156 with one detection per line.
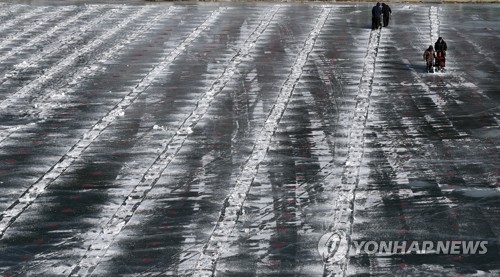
xmin=0 ymin=7 xmax=133 ymax=110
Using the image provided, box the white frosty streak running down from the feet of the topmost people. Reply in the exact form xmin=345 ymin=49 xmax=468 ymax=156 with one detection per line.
xmin=323 ymin=26 xmax=381 ymax=276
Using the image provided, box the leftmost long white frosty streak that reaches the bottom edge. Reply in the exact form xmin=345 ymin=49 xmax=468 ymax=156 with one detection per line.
xmin=67 ymin=6 xmax=279 ymax=276
